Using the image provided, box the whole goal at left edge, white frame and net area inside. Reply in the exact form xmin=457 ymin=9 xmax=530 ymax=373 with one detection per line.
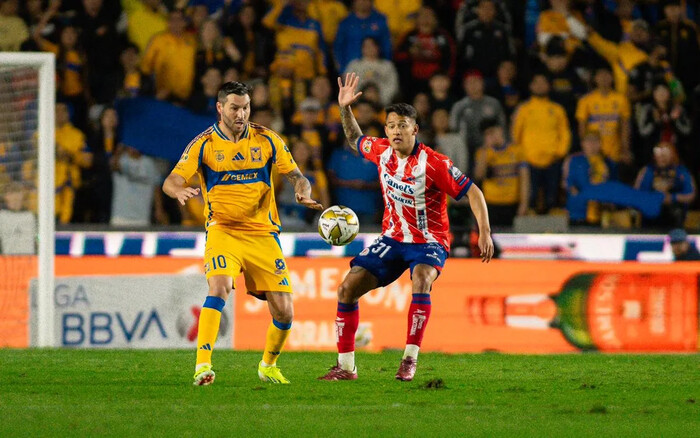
xmin=0 ymin=53 xmax=55 ymax=347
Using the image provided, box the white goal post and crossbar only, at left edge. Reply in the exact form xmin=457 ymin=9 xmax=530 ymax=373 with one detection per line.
xmin=0 ymin=52 xmax=56 ymax=347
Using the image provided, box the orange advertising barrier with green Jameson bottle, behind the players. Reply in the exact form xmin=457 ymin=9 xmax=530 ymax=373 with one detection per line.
xmin=0 ymin=256 xmax=700 ymax=353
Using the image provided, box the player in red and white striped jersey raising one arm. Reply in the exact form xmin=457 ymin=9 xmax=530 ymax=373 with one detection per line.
xmin=320 ymin=73 xmax=493 ymax=381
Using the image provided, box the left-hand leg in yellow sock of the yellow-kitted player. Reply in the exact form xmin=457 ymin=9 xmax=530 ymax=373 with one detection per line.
xmin=194 ymin=275 xmax=233 ymax=386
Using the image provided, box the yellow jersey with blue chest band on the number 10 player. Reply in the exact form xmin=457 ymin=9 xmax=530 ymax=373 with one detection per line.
xmin=173 ymin=123 xmax=297 ymax=235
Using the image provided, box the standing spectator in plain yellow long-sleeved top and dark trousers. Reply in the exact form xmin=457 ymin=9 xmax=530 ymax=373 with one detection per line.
xmin=513 ymin=74 xmax=571 ymax=211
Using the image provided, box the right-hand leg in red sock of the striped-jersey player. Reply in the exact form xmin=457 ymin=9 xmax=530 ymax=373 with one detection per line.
xmin=396 ymin=264 xmax=438 ymax=381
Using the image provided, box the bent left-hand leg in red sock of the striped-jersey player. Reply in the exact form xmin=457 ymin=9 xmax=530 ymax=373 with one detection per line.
xmin=319 ymin=266 xmax=378 ymax=380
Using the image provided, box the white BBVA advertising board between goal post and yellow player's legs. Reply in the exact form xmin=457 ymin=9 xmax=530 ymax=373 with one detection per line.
xmin=30 ymin=274 xmax=233 ymax=348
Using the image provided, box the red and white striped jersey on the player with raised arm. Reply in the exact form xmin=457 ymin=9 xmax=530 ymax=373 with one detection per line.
xmin=357 ymin=136 xmax=472 ymax=250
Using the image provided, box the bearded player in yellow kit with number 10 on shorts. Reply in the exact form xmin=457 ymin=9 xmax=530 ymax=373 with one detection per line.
xmin=163 ymin=82 xmax=322 ymax=385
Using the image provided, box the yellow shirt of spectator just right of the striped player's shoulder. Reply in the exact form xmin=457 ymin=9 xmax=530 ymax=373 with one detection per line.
xmin=476 ymin=143 xmax=527 ymax=205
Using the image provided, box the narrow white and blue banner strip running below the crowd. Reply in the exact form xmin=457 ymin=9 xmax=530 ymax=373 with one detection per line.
xmin=56 ymin=232 xmax=700 ymax=262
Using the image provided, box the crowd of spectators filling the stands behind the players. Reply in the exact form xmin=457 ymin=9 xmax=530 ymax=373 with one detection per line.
xmin=0 ymin=0 xmax=700 ymax=233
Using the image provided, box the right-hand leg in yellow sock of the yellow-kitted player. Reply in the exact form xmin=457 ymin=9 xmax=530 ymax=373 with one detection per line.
xmin=258 ymin=292 xmax=294 ymax=383
